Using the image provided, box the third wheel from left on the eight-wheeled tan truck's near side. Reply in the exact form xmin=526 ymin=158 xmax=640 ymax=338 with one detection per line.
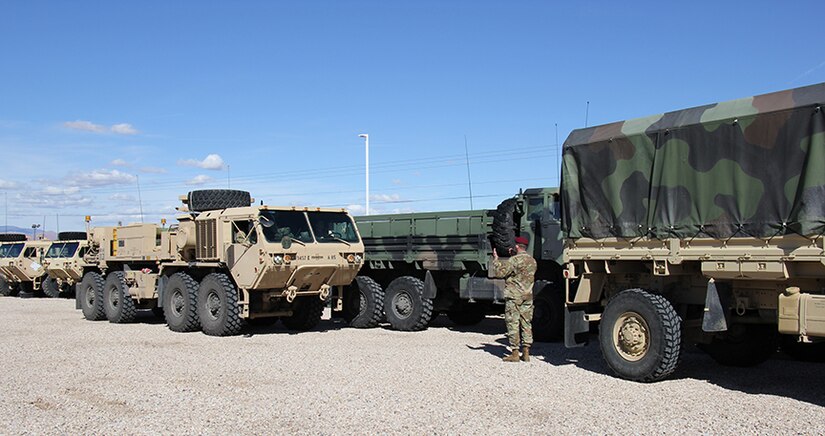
xmin=163 ymin=272 xmax=200 ymax=332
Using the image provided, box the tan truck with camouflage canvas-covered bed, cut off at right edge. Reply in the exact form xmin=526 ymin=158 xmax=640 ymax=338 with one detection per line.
xmin=562 ymin=84 xmax=825 ymax=381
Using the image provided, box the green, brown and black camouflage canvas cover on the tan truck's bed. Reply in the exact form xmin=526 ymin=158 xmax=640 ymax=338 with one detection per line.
xmin=562 ymin=83 xmax=825 ymax=239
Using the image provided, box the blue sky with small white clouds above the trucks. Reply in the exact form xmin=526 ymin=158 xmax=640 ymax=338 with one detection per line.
xmin=0 ymin=0 xmax=825 ymax=230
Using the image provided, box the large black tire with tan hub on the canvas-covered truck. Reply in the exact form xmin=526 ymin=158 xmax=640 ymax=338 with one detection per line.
xmin=599 ymin=289 xmax=682 ymax=382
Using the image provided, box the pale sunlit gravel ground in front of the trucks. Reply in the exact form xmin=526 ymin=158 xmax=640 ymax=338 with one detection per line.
xmin=0 ymin=298 xmax=825 ymax=434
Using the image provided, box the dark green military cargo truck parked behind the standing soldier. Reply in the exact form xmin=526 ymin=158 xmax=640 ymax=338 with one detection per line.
xmin=343 ymin=189 xmax=564 ymax=340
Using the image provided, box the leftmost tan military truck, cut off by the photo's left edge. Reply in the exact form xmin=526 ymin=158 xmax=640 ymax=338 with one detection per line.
xmin=0 ymin=234 xmax=51 ymax=298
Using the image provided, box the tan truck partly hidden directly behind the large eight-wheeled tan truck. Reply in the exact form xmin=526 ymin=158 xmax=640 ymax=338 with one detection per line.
xmin=41 ymin=232 xmax=89 ymax=298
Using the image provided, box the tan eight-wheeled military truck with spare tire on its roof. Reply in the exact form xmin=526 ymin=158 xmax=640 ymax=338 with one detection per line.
xmin=77 ymin=190 xmax=364 ymax=336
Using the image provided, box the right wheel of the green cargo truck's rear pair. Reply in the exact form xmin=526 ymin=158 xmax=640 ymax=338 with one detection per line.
xmin=384 ymin=276 xmax=433 ymax=331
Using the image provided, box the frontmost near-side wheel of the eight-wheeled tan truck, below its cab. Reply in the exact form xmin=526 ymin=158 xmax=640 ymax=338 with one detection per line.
xmin=196 ymin=273 xmax=241 ymax=336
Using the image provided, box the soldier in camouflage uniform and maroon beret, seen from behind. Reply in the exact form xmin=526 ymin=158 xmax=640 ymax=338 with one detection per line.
xmin=493 ymin=236 xmax=536 ymax=362
